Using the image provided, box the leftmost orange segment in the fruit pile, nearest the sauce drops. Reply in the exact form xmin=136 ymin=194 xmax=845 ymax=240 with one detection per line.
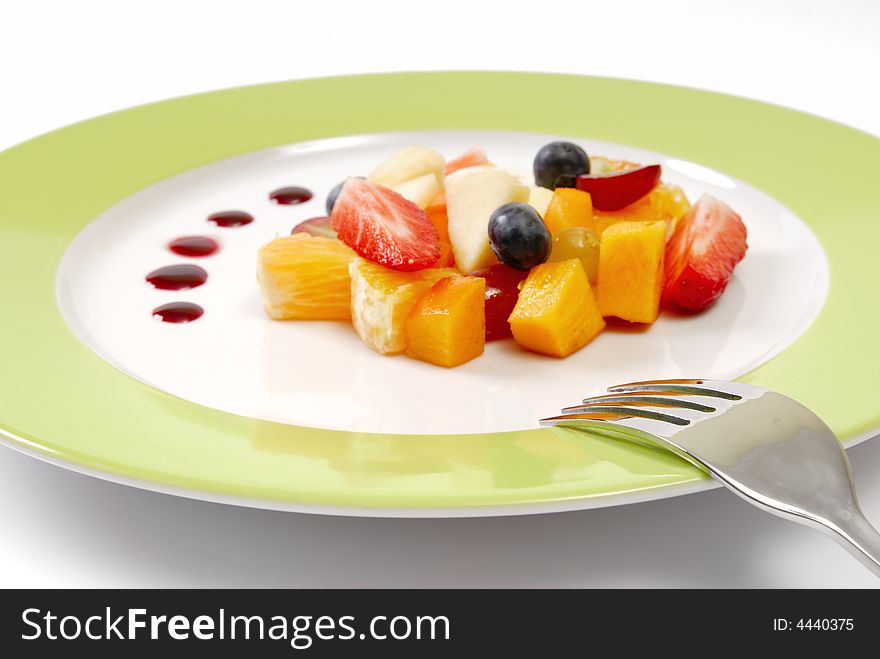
xmin=257 ymin=233 xmax=356 ymax=320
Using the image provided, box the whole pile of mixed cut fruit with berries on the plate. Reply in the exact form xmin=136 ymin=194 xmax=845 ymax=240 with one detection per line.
xmin=257 ymin=142 xmax=746 ymax=368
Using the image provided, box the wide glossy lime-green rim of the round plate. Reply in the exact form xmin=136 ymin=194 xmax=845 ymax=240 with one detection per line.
xmin=0 ymin=72 xmax=880 ymax=516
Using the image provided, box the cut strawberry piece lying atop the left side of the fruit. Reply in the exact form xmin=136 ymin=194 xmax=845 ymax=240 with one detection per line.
xmin=330 ymin=177 xmax=440 ymax=271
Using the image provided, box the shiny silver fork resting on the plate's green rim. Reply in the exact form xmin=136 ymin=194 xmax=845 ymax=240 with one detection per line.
xmin=541 ymin=380 xmax=880 ymax=576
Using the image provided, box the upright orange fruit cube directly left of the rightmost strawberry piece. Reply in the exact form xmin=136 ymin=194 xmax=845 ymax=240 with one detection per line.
xmin=598 ymin=221 xmax=666 ymax=323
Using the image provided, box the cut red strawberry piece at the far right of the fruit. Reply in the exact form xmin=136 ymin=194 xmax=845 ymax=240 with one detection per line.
xmin=663 ymin=195 xmax=747 ymax=311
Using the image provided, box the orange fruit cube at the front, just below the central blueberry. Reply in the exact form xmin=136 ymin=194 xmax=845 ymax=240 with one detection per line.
xmin=509 ymin=259 xmax=605 ymax=357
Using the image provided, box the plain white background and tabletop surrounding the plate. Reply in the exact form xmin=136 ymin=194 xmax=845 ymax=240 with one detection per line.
xmin=0 ymin=0 xmax=880 ymax=587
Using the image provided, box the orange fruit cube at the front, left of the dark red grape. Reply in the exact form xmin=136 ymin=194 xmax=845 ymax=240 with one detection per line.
xmin=406 ymin=277 xmax=486 ymax=368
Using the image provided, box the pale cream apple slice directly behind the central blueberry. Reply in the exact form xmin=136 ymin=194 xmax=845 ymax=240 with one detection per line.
xmin=446 ymin=167 xmax=529 ymax=273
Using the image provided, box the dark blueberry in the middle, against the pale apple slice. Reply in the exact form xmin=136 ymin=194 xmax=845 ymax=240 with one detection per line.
xmin=489 ymin=202 xmax=552 ymax=270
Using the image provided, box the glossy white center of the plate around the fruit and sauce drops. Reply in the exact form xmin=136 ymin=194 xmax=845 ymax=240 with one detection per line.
xmin=57 ymin=132 xmax=828 ymax=434
